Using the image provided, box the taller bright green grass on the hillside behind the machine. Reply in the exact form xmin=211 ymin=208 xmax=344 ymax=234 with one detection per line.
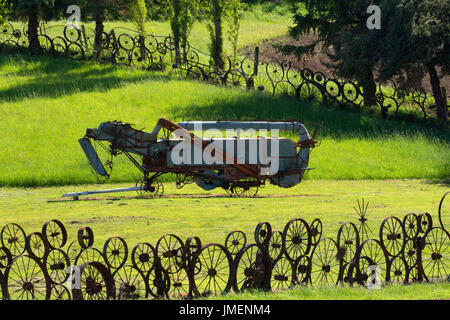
xmin=0 ymin=55 xmax=450 ymax=186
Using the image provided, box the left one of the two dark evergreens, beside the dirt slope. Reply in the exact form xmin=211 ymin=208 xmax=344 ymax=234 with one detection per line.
xmin=283 ymin=0 xmax=386 ymax=105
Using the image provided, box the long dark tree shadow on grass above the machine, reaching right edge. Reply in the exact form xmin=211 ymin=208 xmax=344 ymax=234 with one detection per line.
xmin=168 ymin=92 xmax=450 ymax=143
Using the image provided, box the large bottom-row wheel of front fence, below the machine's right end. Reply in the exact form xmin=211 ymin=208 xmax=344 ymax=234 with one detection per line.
xmin=310 ymin=238 xmax=340 ymax=286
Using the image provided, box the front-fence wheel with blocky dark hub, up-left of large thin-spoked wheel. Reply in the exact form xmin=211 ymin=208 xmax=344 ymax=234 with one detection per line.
xmin=155 ymin=234 xmax=186 ymax=273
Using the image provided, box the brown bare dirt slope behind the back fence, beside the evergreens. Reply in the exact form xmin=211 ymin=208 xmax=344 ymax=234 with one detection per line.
xmin=240 ymin=34 xmax=450 ymax=96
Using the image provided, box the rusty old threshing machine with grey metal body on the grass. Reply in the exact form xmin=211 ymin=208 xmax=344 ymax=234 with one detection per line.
xmin=63 ymin=118 xmax=317 ymax=199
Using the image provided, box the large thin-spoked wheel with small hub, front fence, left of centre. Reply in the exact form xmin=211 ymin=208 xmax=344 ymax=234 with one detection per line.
xmin=193 ymin=243 xmax=233 ymax=296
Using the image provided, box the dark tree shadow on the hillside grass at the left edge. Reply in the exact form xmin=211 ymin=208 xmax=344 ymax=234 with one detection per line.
xmin=0 ymin=55 xmax=171 ymax=102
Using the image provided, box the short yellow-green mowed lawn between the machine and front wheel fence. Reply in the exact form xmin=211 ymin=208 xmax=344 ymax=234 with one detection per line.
xmin=0 ymin=180 xmax=450 ymax=300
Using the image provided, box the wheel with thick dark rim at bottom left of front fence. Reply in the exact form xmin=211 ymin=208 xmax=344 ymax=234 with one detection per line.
xmin=72 ymin=262 xmax=115 ymax=300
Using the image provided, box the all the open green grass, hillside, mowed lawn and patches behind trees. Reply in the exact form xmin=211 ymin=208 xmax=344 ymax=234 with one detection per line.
xmin=0 ymin=6 xmax=450 ymax=300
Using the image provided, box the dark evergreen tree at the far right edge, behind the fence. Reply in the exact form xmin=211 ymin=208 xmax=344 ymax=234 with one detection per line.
xmin=380 ymin=0 xmax=450 ymax=121
